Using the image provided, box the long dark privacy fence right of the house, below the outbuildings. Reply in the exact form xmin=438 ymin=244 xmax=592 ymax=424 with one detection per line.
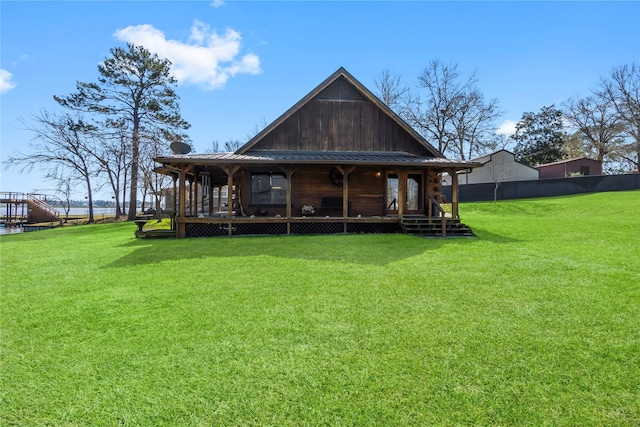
xmin=442 ymin=173 xmax=640 ymax=202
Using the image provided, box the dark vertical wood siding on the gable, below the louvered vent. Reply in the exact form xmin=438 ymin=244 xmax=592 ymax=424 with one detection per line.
xmin=252 ymin=98 xmax=431 ymax=156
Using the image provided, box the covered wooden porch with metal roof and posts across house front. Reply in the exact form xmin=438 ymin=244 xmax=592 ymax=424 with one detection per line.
xmin=156 ymin=153 xmax=470 ymax=241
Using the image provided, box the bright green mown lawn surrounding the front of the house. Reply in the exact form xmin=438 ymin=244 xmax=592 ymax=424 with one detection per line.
xmin=0 ymin=191 xmax=640 ymax=426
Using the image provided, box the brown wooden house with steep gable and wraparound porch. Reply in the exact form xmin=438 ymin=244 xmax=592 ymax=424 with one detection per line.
xmin=154 ymin=68 xmax=478 ymax=237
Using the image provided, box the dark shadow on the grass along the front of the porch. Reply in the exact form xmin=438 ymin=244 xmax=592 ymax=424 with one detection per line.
xmin=106 ymin=234 xmax=478 ymax=268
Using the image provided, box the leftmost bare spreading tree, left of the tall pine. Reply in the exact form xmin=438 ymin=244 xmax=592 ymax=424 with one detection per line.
xmin=7 ymin=111 xmax=97 ymax=223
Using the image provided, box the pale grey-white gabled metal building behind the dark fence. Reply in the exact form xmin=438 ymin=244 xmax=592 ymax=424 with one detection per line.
xmin=442 ymin=150 xmax=540 ymax=185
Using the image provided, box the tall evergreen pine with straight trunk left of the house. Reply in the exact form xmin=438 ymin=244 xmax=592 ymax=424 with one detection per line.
xmin=54 ymin=44 xmax=190 ymax=220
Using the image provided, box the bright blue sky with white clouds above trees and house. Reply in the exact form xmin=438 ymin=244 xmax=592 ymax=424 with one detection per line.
xmin=0 ymin=0 xmax=640 ymax=196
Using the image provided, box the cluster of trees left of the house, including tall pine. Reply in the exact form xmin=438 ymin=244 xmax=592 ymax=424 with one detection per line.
xmin=7 ymin=44 xmax=190 ymax=222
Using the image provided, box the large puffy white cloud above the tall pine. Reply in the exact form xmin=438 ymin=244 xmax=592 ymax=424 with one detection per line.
xmin=114 ymin=21 xmax=262 ymax=89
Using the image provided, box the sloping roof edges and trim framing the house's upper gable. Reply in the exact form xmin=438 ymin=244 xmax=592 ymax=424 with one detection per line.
xmin=235 ymin=67 xmax=444 ymax=158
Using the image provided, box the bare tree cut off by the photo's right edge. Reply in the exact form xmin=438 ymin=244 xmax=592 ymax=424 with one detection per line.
xmin=597 ymin=63 xmax=640 ymax=170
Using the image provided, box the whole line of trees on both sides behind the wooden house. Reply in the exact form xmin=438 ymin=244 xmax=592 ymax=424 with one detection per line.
xmin=7 ymin=49 xmax=640 ymax=222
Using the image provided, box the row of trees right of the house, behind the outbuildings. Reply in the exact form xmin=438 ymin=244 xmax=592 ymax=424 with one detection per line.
xmin=375 ymin=60 xmax=640 ymax=172
